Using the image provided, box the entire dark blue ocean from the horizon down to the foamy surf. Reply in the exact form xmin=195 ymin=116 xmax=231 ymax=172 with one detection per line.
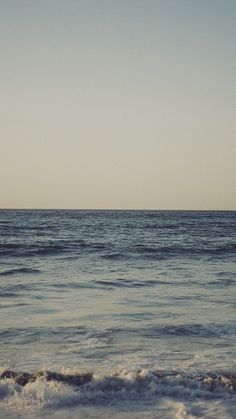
xmin=0 ymin=210 xmax=236 ymax=419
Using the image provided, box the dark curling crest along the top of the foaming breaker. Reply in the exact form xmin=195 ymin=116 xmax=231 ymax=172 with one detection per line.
xmin=0 ymin=369 xmax=236 ymax=396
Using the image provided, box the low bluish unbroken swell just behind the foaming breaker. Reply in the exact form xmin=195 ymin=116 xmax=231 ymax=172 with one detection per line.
xmin=0 ymin=324 xmax=236 ymax=345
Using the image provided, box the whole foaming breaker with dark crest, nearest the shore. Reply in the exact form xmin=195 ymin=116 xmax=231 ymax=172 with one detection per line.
xmin=0 ymin=369 xmax=236 ymax=407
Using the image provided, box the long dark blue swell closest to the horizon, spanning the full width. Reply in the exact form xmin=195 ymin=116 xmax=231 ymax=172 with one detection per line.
xmin=0 ymin=237 xmax=236 ymax=261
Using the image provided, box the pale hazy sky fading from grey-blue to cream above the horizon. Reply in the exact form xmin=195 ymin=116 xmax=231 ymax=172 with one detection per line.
xmin=0 ymin=0 xmax=236 ymax=210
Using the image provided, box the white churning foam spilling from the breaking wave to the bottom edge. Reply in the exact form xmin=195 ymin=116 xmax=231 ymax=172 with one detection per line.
xmin=0 ymin=369 xmax=236 ymax=419
